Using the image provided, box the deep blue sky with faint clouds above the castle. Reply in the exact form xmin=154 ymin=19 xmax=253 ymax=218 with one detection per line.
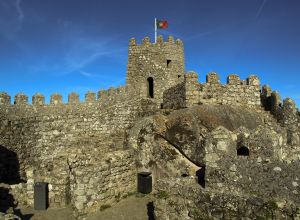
xmin=0 ymin=0 xmax=300 ymax=107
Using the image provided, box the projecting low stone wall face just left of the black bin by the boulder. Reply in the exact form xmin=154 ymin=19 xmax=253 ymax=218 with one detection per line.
xmin=70 ymin=150 xmax=137 ymax=218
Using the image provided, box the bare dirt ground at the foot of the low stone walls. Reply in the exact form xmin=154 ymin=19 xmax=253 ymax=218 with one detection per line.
xmin=15 ymin=196 xmax=154 ymax=220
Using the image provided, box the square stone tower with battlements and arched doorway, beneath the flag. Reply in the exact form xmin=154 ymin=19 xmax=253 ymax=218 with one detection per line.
xmin=126 ymin=36 xmax=185 ymax=104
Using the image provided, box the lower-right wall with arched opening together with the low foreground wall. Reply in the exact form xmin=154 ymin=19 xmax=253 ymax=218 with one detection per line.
xmin=155 ymin=124 xmax=300 ymax=219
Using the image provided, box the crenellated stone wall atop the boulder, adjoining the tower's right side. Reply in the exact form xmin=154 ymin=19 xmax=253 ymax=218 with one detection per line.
xmin=164 ymin=72 xmax=261 ymax=109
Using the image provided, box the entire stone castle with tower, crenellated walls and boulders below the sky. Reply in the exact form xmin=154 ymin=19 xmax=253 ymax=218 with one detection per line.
xmin=0 ymin=37 xmax=300 ymax=219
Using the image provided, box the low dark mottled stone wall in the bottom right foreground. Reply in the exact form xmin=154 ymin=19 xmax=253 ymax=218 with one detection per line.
xmin=154 ymin=178 xmax=300 ymax=220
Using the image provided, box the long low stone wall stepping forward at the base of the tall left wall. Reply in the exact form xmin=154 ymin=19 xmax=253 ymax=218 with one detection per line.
xmin=7 ymin=148 xmax=137 ymax=219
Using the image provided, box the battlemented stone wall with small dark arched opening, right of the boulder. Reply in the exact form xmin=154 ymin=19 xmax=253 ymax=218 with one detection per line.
xmin=204 ymin=126 xmax=300 ymax=204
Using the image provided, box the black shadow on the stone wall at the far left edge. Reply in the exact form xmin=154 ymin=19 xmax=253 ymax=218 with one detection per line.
xmin=0 ymin=145 xmax=23 ymax=184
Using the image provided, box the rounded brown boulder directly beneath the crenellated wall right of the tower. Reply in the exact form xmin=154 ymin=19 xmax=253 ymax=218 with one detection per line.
xmin=165 ymin=105 xmax=263 ymax=166
